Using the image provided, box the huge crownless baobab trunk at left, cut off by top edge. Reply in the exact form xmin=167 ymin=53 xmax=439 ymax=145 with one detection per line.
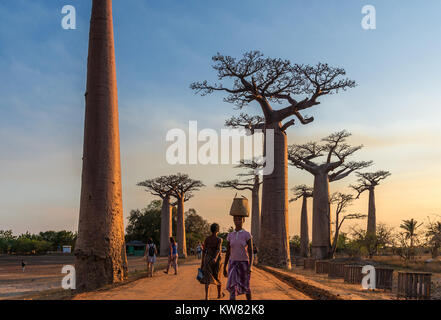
xmin=75 ymin=0 xmax=127 ymax=291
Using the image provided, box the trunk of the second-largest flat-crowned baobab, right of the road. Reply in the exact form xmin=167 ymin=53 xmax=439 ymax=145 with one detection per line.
xmin=312 ymin=172 xmax=331 ymax=259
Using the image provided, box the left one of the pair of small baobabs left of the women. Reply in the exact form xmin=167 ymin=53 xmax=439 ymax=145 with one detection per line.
xmin=137 ymin=176 xmax=175 ymax=257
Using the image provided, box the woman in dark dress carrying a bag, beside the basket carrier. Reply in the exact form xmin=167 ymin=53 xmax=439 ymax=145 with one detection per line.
xmin=200 ymin=223 xmax=225 ymax=300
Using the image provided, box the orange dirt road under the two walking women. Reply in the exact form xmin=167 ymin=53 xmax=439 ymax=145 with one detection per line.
xmin=76 ymin=261 xmax=310 ymax=300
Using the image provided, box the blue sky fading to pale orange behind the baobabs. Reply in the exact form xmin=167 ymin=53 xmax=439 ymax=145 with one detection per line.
xmin=0 ymin=0 xmax=441 ymax=235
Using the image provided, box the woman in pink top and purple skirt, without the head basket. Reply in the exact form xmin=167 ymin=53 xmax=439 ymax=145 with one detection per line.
xmin=224 ymin=216 xmax=253 ymax=300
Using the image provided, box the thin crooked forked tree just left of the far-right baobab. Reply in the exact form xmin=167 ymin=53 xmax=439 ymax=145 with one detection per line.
xmin=330 ymin=192 xmax=366 ymax=257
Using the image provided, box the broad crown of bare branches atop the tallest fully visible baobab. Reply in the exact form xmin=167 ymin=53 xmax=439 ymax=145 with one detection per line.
xmin=190 ymin=51 xmax=356 ymax=124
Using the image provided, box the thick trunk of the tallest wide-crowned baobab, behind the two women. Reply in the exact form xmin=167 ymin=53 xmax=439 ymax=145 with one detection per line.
xmin=259 ymin=123 xmax=291 ymax=269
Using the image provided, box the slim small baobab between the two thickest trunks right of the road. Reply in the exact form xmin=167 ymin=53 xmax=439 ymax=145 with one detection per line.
xmin=289 ymin=184 xmax=313 ymax=258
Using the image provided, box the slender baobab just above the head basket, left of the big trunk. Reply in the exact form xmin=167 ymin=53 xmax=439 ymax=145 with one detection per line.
xmin=215 ymin=160 xmax=262 ymax=245
